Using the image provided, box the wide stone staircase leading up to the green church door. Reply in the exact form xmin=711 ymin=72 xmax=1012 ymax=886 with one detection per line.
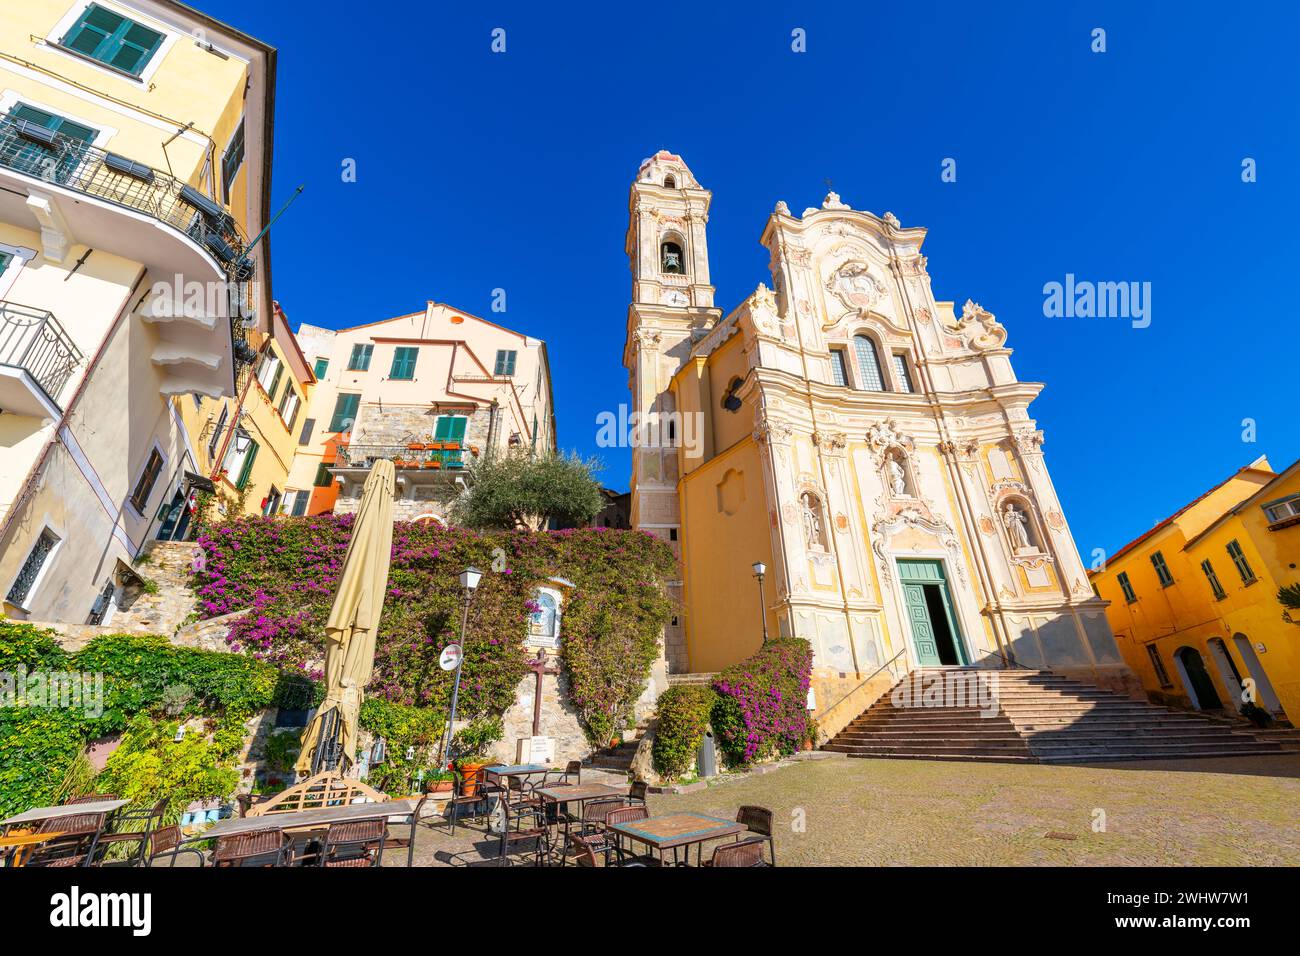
xmin=823 ymin=667 xmax=1282 ymax=763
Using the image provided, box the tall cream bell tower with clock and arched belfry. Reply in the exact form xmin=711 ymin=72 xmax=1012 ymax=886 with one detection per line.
xmin=623 ymin=150 xmax=722 ymax=671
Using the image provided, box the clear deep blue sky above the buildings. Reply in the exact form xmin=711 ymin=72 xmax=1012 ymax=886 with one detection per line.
xmin=208 ymin=0 xmax=1300 ymax=561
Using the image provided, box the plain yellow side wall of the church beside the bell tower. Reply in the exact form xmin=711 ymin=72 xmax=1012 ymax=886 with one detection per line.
xmin=679 ymin=438 xmax=779 ymax=672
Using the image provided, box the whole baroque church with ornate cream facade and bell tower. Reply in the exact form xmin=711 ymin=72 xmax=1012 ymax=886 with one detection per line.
xmin=624 ymin=151 xmax=1136 ymax=734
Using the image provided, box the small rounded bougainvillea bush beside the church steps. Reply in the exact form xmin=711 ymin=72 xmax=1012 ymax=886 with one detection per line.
xmin=712 ymin=637 xmax=813 ymax=766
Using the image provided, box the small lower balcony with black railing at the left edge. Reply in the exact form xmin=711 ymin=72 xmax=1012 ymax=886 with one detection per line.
xmin=0 ymin=300 xmax=83 ymax=419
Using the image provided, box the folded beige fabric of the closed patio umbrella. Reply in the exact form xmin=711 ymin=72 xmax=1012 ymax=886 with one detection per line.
xmin=295 ymin=460 xmax=395 ymax=773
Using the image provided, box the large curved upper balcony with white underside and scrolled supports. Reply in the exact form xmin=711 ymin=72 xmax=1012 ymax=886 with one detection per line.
xmin=0 ymin=118 xmax=254 ymax=395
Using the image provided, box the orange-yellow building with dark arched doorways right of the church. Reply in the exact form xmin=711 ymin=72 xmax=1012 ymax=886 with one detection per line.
xmin=1091 ymin=455 xmax=1300 ymax=721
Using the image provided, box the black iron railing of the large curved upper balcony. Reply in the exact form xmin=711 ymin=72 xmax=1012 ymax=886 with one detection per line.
xmin=0 ymin=118 xmax=254 ymax=378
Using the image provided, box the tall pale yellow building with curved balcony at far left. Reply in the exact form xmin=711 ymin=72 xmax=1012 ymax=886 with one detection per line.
xmin=0 ymin=0 xmax=274 ymax=623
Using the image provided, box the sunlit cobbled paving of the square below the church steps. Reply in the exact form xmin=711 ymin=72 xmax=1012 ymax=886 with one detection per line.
xmin=385 ymin=753 xmax=1300 ymax=866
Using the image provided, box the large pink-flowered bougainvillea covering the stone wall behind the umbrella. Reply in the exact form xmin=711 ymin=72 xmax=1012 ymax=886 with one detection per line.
xmin=191 ymin=515 xmax=675 ymax=743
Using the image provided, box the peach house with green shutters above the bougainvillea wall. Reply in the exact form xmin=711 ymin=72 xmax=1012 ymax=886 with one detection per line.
xmin=283 ymin=302 xmax=555 ymax=522
